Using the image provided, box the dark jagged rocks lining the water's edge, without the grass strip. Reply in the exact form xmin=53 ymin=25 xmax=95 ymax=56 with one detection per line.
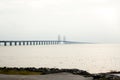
xmin=0 ymin=67 xmax=120 ymax=80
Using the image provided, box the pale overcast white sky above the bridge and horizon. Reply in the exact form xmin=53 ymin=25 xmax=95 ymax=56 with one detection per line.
xmin=0 ymin=0 xmax=120 ymax=43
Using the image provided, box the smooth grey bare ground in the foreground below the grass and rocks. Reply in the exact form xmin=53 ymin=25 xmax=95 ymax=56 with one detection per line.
xmin=0 ymin=72 xmax=93 ymax=80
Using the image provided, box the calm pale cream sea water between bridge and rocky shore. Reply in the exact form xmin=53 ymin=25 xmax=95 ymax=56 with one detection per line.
xmin=0 ymin=44 xmax=120 ymax=73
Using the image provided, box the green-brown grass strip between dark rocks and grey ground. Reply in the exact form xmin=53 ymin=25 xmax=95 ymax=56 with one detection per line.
xmin=0 ymin=70 xmax=42 ymax=75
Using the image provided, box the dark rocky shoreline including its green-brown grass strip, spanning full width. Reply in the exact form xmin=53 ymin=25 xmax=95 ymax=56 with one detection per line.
xmin=0 ymin=67 xmax=120 ymax=80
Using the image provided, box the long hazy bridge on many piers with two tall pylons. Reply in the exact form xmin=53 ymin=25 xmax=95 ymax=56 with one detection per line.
xmin=0 ymin=36 xmax=79 ymax=46
